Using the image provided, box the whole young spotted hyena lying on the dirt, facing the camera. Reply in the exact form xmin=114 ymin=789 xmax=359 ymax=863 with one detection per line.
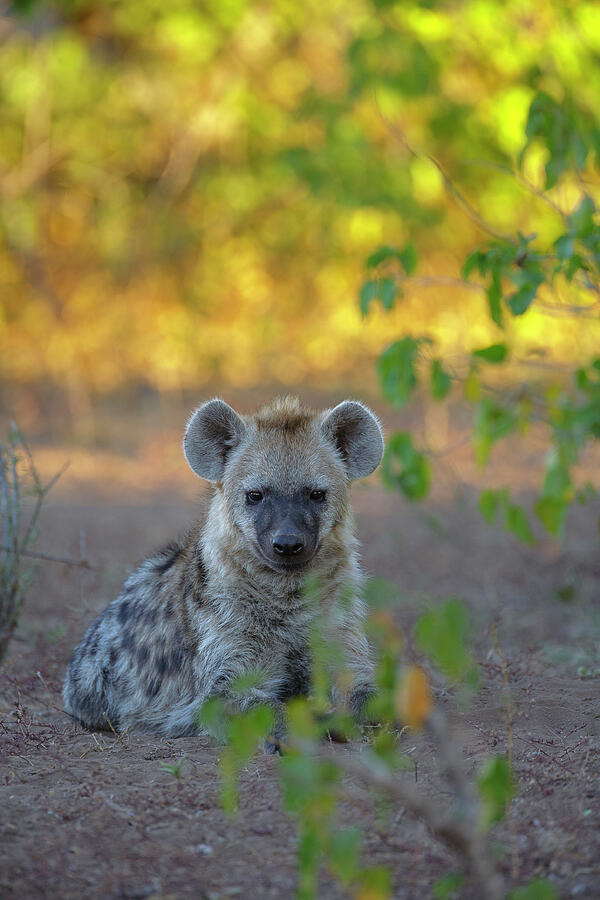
xmin=63 ymin=397 xmax=383 ymax=737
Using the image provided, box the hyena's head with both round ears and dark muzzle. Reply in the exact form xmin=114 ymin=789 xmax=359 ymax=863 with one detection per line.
xmin=183 ymin=397 xmax=383 ymax=572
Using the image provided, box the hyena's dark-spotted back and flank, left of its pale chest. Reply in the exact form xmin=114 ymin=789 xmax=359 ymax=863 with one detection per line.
xmin=63 ymin=540 xmax=204 ymax=734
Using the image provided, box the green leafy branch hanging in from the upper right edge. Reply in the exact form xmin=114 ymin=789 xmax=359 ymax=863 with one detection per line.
xmin=360 ymin=93 xmax=600 ymax=543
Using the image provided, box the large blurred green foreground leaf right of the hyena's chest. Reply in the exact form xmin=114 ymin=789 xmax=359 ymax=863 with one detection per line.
xmin=415 ymin=599 xmax=477 ymax=685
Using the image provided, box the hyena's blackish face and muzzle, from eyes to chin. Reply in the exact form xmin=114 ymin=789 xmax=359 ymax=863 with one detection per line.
xmin=247 ymin=489 xmax=326 ymax=570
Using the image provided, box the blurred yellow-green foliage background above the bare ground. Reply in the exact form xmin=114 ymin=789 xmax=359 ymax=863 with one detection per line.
xmin=0 ymin=0 xmax=600 ymax=407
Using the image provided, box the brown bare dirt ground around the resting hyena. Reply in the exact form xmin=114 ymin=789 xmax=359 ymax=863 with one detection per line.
xmin=0 ymin=400 xmax=600 ymax=900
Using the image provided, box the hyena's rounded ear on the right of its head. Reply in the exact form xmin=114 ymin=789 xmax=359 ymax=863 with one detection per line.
xmin=321 ymin=400 xmax=383 ymax=478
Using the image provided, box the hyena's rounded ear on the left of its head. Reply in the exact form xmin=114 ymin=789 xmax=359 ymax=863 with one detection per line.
xmin=183 ymin=399 xmax=246 ymax=481
